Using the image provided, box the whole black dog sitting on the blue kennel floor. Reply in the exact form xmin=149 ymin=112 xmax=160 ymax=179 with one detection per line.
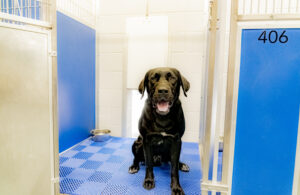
xmin=129 ymin=68 xmax=190 ymax=195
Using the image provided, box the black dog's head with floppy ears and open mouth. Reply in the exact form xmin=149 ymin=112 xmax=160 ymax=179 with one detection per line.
xmin=139 ymin=68 xmax=190 ymax=115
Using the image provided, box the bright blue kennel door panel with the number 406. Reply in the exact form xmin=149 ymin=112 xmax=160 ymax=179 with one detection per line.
xmin=232 ymin=29 xmax=300 ymax=195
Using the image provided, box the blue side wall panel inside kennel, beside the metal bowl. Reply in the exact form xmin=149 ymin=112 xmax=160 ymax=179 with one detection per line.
xmin=57 ymin=12 xmax=96 ymax=152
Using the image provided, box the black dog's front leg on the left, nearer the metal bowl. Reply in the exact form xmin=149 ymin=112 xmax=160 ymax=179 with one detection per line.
xmin=143 ymin=138 xmax=155 ymax=190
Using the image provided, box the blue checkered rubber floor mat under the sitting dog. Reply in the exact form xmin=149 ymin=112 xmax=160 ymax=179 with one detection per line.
xmin=59 ymin=137 xmax=202 ymax=195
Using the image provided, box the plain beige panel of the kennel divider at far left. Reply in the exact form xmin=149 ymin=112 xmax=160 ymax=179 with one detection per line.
xmin=0 ymin=27 xmax=51 ymax=195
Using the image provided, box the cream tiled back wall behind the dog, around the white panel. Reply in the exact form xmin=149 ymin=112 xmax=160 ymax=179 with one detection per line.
xmin=96 ymin=0 xmax=208 ymax=141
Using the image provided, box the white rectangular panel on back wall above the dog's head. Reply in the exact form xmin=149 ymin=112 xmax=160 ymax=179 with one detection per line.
xmin=126 ymin=16 xmax=169 ymax=89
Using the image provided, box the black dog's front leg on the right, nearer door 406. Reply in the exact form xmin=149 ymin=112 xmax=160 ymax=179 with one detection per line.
xmin=171 ymin=139 xmax=184 ymax=195
